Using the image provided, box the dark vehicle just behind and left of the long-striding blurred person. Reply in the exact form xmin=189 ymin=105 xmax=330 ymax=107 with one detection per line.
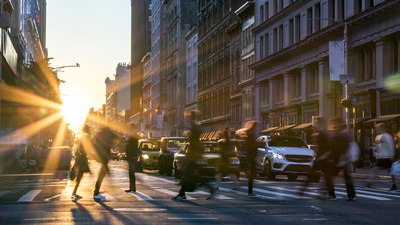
xmin=158 ymin=137 xmax=189 ymax=176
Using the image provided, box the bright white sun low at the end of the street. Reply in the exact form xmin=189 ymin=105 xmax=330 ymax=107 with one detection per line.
xmin=61 ymin=94 xmax=89 ymax=132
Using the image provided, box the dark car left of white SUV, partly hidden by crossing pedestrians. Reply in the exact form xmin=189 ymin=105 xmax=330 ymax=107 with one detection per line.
xmin=174 ymin=141 xmax=240 ymax=178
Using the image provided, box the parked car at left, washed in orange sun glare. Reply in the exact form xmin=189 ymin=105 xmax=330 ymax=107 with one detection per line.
xmin=36 ymin=146 xmax=72 ymax=170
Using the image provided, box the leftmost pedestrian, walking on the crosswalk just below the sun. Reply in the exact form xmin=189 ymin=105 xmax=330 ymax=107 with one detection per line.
xmin=71 ymin=125 xmax=90 ymax=200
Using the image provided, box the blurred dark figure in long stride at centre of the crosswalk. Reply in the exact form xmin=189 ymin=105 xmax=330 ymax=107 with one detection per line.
xmin=172 ymin=111 xmax=215 ymax=201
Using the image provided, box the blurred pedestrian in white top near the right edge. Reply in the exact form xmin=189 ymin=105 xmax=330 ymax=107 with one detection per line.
xmin=365 ymin=123 xmax=397 ymax=191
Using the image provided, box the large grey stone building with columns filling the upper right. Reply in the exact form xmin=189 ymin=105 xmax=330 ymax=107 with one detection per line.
xmin=250 ymin=0 xmax=400 ymax=149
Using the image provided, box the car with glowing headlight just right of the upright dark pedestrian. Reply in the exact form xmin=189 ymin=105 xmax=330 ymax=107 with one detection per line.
xmin=139 ymin=139 xmax=160 ymax=170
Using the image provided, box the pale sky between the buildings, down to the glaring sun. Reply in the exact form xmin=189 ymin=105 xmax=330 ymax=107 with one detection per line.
xmin=46 ymin=0 xmax=131 ymax=131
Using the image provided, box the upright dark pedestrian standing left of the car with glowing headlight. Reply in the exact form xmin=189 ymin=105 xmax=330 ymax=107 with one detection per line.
xmin=125 ymin=136 xmax=142 ymax=192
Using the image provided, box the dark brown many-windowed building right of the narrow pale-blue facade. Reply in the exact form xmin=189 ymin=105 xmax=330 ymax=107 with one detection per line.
xmin=197 ymin=0 xmax=246 ymax=139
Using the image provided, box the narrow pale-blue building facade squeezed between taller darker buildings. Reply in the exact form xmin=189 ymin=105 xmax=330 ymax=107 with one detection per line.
xmin=185 ymin=27 xmax=198 ymax=111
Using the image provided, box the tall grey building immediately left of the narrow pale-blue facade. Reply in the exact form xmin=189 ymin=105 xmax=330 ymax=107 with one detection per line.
xmin=160 ymin=0 xmax=197 ymax=136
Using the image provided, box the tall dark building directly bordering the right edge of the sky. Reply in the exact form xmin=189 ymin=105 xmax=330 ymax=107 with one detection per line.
xmin=130 ymin=0 xmax=151 ymax=122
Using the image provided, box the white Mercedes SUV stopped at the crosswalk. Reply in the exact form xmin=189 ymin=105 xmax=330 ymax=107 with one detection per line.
xmin=256 ymin=135 xmax=320 ymax=182
